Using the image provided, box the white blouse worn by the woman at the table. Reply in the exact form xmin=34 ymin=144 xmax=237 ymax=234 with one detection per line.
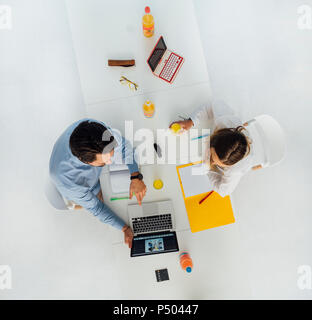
xmin=190 ymin=101 xmax=255 ymax=197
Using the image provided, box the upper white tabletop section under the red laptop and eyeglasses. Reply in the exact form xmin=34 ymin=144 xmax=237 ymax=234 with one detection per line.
xmin=66 ymin=0 xmax=208 ymax=105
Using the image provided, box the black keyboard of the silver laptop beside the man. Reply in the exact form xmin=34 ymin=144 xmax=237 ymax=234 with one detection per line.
xmin=132 ymin=213 xmax=172 ymax=233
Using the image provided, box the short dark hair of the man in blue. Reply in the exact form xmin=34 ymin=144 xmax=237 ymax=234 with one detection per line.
xmin=69 ymin=121 xmax=114 ymax=163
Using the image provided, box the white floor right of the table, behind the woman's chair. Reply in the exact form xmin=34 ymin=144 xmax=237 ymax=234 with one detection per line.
xmin=194 ymin=0 xmax=312 ymax=299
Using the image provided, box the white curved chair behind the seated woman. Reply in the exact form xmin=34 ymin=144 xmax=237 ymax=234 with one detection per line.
xmin=244 ymin=114 xmax=285 ymax=169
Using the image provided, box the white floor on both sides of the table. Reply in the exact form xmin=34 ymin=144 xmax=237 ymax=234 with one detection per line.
xmin=0 ymin=0 xmax=312 ymax=299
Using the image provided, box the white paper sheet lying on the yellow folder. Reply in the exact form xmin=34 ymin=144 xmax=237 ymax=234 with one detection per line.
xmin=179 ymin=163 xmax=212 ymax=198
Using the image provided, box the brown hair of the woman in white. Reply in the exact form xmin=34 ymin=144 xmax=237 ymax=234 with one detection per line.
xmin=210 ymin=126 xmax=250 ymax=166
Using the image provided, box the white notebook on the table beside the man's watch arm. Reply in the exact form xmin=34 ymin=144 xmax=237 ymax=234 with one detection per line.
xmin=109 ymin=164 xmax=130 ymax=193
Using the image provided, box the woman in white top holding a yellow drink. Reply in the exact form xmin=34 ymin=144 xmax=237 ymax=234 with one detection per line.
xmin=170 ymin=101 xmax=254 ymax=197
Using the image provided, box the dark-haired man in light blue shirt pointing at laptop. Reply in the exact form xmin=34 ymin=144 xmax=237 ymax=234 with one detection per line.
xmin=50 ymin=119 xmax=146 ymax=247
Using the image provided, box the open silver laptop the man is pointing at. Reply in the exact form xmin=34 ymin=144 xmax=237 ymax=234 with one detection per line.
xmin=128 ymin=200 xmax=179 ymax=257
